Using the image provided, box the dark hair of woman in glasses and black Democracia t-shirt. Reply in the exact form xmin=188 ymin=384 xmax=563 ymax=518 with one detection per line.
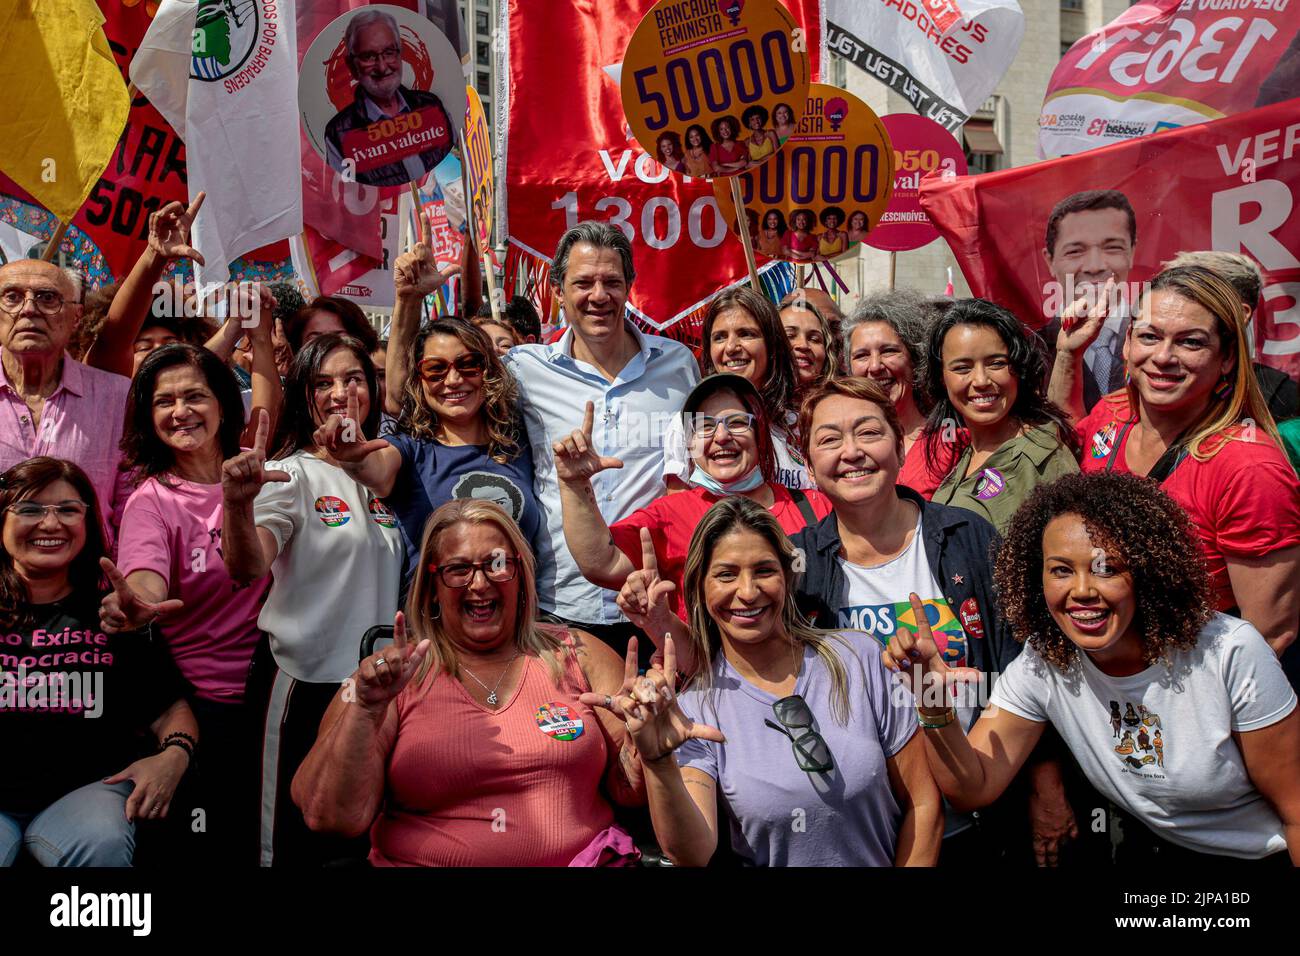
xmin=0 ymin=457 xmax=108 ymax=630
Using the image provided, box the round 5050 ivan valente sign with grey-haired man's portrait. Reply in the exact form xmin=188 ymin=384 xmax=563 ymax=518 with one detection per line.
xmin=298 ymin=4 xmax=465 ymax=186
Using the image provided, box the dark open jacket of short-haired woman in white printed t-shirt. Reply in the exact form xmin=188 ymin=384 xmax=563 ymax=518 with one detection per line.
xmin=790 ymin=485 xmax=1021 ymax=675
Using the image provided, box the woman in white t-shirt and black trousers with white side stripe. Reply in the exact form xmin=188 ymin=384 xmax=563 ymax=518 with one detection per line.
xmin=221 ymin=333 xmax=404 ymax=866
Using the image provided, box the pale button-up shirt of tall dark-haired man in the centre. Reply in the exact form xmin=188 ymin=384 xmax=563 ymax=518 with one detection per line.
xmin=504 ymin=323 xmax=699 ymax=624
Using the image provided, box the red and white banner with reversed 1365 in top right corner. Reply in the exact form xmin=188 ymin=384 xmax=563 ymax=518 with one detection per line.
xmin=1039 ymin=0 xmax=1300 ymax=156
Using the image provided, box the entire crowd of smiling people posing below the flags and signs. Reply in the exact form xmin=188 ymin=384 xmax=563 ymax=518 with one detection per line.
xmin=0 ymin=195 xmax=1300 ymax=866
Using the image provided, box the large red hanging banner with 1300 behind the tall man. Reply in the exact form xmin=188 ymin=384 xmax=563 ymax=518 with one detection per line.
xmin=506 ymin=0 xmax=822 ymax=329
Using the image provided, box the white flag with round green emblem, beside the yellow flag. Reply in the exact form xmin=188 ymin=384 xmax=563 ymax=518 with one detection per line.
xmin=131 ymin=0 xmax=303 ymax=284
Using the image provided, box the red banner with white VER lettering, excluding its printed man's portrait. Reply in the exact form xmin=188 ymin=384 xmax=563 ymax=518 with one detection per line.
xmin=920 ymin=99 xmax=1300 ymax=377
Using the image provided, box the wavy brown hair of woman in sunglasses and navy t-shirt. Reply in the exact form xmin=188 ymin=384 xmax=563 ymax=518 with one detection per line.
xmin=395 ymin=316 xmax=523 ymax=464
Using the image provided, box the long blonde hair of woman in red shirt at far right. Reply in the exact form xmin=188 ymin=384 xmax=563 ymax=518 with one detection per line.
xmin=1128 ymin=265 xmax=1282 ymax=462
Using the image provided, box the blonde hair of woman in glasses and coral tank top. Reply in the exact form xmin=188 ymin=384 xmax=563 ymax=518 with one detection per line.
xmin=404 ymin=498 xmax=564 ymax=693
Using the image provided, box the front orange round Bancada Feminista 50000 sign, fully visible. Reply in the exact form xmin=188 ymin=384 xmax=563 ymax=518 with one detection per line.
xmin=621 ymin=0 xmax=811 ymax=179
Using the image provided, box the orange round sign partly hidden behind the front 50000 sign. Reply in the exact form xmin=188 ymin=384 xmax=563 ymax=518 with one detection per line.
xmin=714 ymin=83 xmax=893 ymax=263
